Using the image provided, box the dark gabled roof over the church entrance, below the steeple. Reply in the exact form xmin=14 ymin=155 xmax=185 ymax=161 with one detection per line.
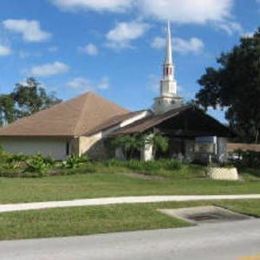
xmin=111 ymin=105 xmax=235 ymax=137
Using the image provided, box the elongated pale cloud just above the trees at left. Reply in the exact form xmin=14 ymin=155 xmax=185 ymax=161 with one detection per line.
xmin=30 ymin=61 xmax=70 ymax=77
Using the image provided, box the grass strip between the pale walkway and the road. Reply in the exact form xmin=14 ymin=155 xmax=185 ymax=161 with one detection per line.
xmin=0 ymin=200 xmax=260 ymax=240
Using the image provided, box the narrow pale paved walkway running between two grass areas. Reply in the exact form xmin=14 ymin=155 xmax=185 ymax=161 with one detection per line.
xmin=0 ymin=194 xmax=260 ymax=213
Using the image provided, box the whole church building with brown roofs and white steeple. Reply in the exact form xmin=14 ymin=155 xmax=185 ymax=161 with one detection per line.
xmin=0 ymin=23 xmax=233 ymax=161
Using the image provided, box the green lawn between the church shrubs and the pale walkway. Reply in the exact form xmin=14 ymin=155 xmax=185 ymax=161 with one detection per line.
xmin=0 ymin=172 xmax=260 ymax=204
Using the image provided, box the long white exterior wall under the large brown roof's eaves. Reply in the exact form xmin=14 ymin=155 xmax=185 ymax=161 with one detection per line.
xmin=0 ymin=137 xmax=67 ymax=160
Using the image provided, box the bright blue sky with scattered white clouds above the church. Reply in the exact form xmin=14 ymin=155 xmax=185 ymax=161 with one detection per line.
xmin=0 ymin=0 xmax=260 ymax=121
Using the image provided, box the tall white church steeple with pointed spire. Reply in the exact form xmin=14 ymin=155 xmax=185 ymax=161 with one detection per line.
xmin=154 ymin=21 xmax=182 ymax=113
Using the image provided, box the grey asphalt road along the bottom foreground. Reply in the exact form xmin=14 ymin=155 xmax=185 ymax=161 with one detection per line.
xmin=0 ymin=219 xmax=260 ymax=260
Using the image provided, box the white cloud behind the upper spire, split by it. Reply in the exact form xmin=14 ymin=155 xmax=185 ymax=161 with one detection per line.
xmin=151 ymin=37 xmax=205 ymax=54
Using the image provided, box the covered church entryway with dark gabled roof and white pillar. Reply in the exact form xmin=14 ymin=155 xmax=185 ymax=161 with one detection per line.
xmin=112 ymin=106 xmax=234 ymax=161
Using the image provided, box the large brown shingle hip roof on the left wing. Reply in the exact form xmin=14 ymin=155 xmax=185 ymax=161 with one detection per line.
xmin=0 ymin=92 xmax=129 ymax=137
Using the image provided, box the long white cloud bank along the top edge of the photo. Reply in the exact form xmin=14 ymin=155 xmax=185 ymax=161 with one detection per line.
xmin=50 ymin=0 xmax=241 ymax=34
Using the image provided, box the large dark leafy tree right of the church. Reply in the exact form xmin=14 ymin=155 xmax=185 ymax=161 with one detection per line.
xmin=196 ymin=28 xmax=260 ymax=143
